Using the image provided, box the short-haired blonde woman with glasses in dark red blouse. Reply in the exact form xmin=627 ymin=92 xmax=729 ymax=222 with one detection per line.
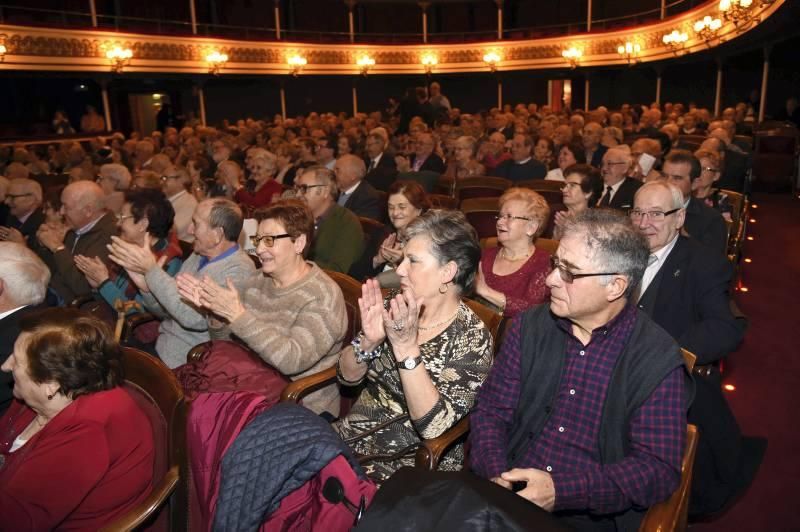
xmin=475 ymin=187 xmax=550 ymax=317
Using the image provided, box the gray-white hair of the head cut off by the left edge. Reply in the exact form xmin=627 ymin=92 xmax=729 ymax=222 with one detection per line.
xmin=0 ymin=242 xmax=50 ymax=306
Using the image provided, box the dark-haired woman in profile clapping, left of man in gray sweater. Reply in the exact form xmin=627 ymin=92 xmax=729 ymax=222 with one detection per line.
xmin=75 ymin=188 xmax=182 ymax=308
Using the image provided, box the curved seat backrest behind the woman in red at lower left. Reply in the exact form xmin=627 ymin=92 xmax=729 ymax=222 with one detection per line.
xmin=123 ymin=347 xmax=189 ymax=530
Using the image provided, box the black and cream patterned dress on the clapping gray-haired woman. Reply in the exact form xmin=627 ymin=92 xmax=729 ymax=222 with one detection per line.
xmin=333 ymin=303 xmax=494 ymax=482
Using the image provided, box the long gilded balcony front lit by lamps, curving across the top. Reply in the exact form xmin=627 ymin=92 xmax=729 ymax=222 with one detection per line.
xmin=0 ymin=0 xmax=786 ymax=75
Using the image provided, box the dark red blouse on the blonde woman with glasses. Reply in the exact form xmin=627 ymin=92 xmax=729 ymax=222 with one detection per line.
xmin=481 ymin=247 xmax=550 ymax=318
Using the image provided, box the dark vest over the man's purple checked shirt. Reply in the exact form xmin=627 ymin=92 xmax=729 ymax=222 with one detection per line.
xmin=507 ymin=305 xmax=691 ymax=530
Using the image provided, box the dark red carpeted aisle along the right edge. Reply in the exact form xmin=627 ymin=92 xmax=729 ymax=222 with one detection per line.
xmin=691 ymin=194 xmax=800 ymax=532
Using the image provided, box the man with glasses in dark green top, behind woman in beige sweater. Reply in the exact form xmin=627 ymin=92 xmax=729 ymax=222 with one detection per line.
xmin=294 ymin=166 xmax=364 ymax=273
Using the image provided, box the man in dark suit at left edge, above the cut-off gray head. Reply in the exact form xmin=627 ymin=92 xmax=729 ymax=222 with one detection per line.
xmin=0 ymin=179 xmax=44 ymax=244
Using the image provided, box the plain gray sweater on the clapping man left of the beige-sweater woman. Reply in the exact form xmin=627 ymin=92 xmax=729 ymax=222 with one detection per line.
xmin=143 ymin=246 xmax=255 ymax=368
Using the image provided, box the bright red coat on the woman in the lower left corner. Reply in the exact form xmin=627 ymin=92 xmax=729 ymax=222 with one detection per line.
xmin=0 ymin=388 xmax=154 ymax=531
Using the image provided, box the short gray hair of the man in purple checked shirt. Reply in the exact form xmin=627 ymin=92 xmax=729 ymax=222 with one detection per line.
xmin=561 ymin=209 xmax=650 ymax=298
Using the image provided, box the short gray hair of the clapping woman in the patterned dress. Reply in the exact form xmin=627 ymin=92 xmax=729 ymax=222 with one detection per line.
xmin=404 ymin=209 xmax=481 ymax=294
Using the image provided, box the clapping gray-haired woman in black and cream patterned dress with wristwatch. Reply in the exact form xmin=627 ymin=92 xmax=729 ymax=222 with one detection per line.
xmin=333 ymin=210 xmax=493 ymax=482
